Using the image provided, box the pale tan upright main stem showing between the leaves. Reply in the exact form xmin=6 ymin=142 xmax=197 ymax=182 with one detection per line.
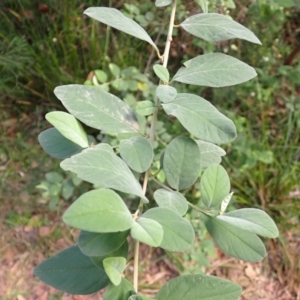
xmin=133 ymin=0 xmax=177 ymax=293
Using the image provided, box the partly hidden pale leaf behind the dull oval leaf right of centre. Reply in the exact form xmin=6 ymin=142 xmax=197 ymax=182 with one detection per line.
xmin=195 ymin=141 xmax=226 ymax=169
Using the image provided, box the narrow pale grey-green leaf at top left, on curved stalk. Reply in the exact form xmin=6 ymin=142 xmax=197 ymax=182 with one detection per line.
xmin=84 ymin=7 xmax=157 ymax=50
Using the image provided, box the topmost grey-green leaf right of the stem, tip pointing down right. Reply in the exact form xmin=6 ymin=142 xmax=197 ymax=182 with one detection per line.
xmin=180 ymin=13 xmax=261 ymax=45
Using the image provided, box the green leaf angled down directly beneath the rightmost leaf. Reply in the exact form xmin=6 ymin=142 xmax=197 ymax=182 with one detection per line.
xmin=203 ymin=215 xmax=266 ymax=262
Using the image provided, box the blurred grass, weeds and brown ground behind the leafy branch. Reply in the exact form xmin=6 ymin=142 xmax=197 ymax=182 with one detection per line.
xmin=0 ymin=0 xmax=300 ymax=299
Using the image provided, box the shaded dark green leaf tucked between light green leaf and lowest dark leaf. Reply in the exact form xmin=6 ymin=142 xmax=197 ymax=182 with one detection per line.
xmin=78 ymin=231 xmax=129 ymax=256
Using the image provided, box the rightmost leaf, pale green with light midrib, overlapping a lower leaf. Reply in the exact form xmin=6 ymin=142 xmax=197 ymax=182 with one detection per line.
xmin=218 ymin=208 xmax=279 ymax=239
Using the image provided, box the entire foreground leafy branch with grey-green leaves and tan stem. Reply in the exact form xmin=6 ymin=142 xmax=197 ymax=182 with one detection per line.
xmin=34 ymin=0 xmax=278 ymax=300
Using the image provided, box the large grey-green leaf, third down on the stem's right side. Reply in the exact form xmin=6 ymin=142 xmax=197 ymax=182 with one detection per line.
xmin=162 ymin=93 xmax=236 ymax=144
